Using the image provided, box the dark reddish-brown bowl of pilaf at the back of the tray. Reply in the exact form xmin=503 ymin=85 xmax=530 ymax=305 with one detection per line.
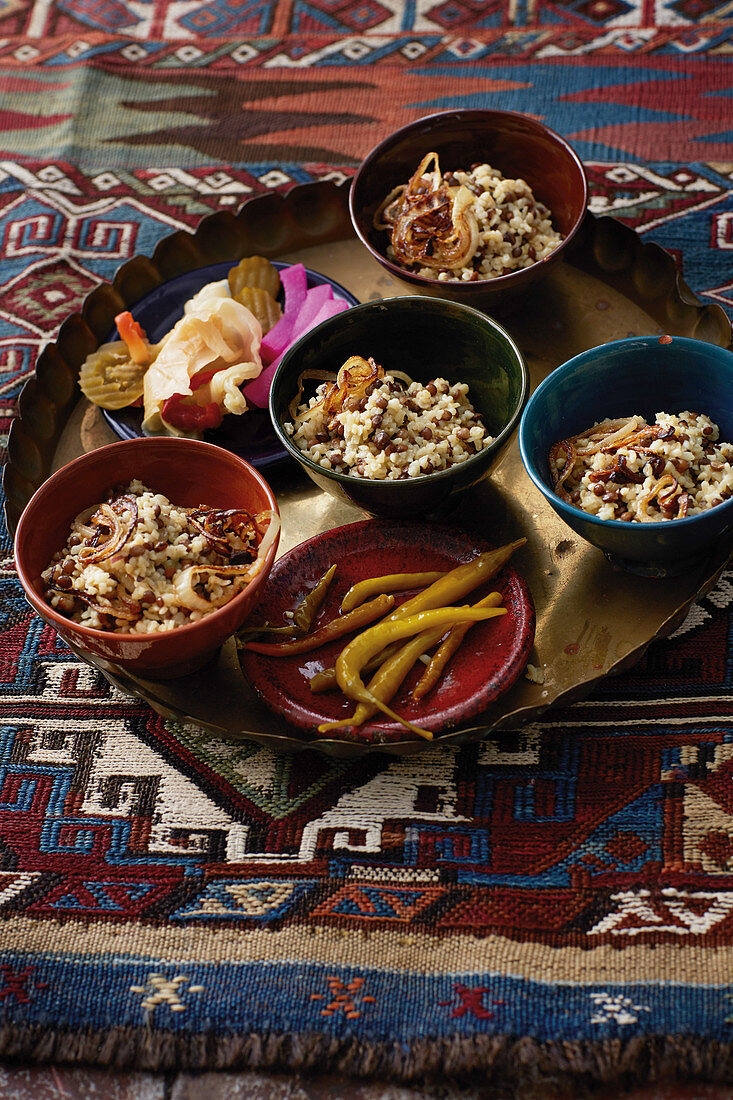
xmin=349 ymin=110 xmax=588 ymax=308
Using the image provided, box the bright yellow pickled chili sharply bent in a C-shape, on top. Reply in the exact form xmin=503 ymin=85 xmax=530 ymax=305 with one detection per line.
xmin=318 ymin=607 xmax=506 ymax=740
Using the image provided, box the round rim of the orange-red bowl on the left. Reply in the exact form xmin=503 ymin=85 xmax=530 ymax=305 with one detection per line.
xmin=13 ymin=436 xmax=280 ymax=646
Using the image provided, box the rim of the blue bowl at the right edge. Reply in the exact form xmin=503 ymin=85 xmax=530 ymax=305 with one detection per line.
xmin=517 ymin=333 xmax=733 ymax=537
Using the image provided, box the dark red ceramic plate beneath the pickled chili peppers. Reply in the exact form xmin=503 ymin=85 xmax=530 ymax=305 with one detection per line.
xmin=240 ymin=519 xmax=535 ymax=741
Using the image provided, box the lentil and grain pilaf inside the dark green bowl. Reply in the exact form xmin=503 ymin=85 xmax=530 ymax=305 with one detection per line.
xmin=285 ymin=355 xmax=493 ymax=481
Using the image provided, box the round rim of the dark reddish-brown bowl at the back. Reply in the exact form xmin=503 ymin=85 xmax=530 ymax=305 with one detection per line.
xmin=349 ymin=107 xmax=589 ymax=295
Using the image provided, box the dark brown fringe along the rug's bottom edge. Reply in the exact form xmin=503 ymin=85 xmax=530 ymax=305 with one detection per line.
xmin=0 ymin=1025 xmax=733 ymax=1095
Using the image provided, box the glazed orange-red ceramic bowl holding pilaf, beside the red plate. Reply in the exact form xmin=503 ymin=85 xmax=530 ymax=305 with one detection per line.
xmin=15 ymin=438 xmax=277 ymax=680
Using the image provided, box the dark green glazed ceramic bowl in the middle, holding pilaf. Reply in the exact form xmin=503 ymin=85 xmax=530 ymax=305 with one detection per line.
xmin=270 ymin=297 xmax=529 ymax=517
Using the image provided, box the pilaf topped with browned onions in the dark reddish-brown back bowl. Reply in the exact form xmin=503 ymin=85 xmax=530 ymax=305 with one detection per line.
xmin=374 ymin=153 xmax=562 ymax=283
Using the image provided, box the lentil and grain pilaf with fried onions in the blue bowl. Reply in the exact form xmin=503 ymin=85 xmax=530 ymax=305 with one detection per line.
xmin=549 ymin=411 xmax=733 ymax=524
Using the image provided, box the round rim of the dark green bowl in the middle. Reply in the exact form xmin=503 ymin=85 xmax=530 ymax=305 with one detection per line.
xmin=269 ymin=294 xmax=529 ymax=493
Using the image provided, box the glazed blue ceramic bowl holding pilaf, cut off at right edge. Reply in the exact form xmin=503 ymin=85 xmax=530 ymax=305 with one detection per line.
xmin=519 ymin=337 xmax=733 ymax=576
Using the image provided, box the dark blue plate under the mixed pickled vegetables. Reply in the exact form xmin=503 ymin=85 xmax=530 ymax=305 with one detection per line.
xmin=101 ymin=266 xmax=359 ymax=470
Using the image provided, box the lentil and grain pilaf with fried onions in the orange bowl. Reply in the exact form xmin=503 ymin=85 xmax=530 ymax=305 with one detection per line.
xmin=42 ymin=480 xmax=280 ymax=634
